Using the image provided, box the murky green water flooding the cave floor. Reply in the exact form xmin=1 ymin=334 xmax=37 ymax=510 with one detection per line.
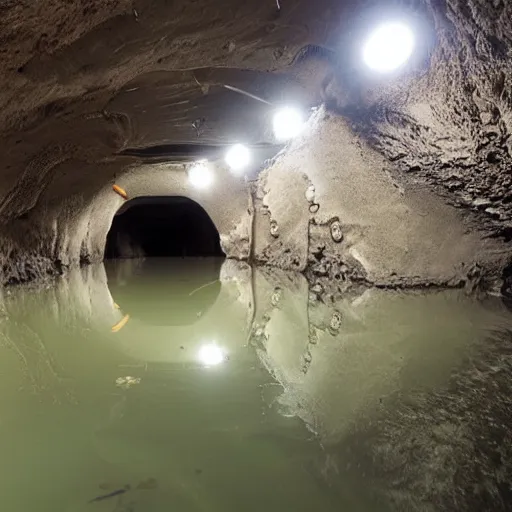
xmin=0 ymin=260 xmax=512 ymax=512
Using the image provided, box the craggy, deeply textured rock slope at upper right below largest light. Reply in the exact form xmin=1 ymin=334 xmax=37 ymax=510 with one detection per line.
xmin=327 ymin=0 xmax=512 ymax=240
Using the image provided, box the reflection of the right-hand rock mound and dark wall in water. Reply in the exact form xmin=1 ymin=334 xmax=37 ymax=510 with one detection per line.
xmin=244 ymin=262 xmax=512 ymax=511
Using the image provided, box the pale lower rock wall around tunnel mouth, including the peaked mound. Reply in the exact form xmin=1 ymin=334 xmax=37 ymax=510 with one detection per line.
xmin=0 ymin=109 xmax=509 ymax=291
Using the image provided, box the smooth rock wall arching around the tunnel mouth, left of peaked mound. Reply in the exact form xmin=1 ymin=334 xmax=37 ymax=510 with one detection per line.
xmin=0 ymin=158 xmax=252 ymax=283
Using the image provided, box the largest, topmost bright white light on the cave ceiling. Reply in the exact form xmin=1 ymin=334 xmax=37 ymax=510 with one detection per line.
xmin=363 ymin=23 xmax=414 ymax=73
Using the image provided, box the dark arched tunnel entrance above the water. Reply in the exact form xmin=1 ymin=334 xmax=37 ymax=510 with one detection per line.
xmin=105 ymin=196 xmax=224 ymax=259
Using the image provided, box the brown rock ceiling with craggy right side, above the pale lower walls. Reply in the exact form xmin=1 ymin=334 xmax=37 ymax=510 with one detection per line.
xmin=0 ymin=0 xmax=512 ymax=239
